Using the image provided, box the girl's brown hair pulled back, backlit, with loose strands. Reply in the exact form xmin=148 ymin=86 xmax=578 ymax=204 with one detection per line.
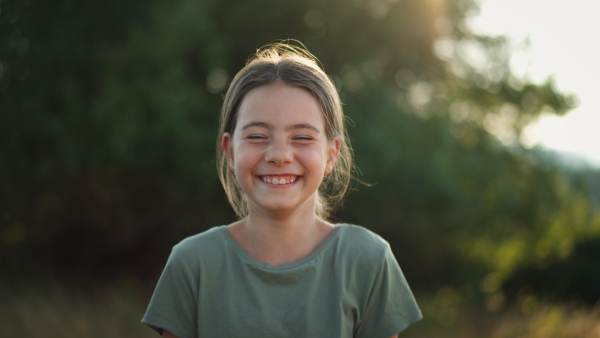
xmin=217 ymin=41 xmax=353 ymax=218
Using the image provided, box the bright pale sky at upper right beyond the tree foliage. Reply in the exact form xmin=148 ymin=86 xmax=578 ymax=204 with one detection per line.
xmin=469 ymin=0 xmax=600 ymax=167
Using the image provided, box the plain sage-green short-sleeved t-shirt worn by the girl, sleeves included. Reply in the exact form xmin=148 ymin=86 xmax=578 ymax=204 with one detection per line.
xmin=142 ymin=225 xmax=422 ymax=338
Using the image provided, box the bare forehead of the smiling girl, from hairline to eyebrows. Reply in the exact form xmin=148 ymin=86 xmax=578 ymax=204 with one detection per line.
xmin=236 ymin=82 xmax=325 ymax=131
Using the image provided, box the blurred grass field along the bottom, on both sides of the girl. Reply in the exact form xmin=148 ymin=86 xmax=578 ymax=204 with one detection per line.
xmin=0 ymin=286 xmax=600 ymax=338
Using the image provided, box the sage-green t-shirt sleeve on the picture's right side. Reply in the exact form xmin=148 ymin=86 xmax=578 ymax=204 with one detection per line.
xmin=355 ymin=245 xmax=423 ymax=338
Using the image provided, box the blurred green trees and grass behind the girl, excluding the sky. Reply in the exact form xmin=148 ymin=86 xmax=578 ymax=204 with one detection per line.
xmin=0 ymin=0 xmax=600 ymax=337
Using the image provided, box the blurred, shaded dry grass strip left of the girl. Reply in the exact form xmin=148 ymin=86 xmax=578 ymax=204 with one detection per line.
xmin=0 ymin=287 xmax=155 ymax=338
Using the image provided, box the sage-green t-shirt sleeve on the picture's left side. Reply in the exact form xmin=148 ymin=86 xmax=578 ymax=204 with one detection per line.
xmin=142 ymin=245 xmax=199 ymax=338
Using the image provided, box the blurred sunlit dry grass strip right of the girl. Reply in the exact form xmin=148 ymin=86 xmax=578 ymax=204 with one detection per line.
xmin=400 ymin=298 xmax=600 ymax=338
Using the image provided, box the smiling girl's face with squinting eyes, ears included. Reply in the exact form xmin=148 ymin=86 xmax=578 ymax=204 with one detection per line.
xmin=221 ymin=82 xmax=341 ymax=218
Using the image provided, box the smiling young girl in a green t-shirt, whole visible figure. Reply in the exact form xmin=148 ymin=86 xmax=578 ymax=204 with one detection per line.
xmin=142 ymin=44 xmax=421 ymax=338
